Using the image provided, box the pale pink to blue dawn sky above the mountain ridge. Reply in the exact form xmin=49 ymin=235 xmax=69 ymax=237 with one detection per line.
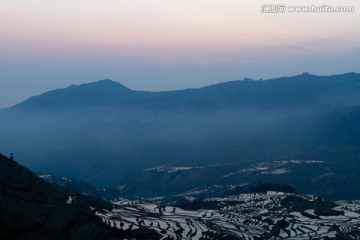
xmin=0 ymin=0 xmax=360 ymax=108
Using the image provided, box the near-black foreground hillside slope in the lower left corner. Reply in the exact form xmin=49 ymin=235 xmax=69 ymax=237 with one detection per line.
xmin=0 ymin=154 xmax=160 ymax=239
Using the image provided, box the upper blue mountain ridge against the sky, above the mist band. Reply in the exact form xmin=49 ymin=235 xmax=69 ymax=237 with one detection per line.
xmin=14 ymin=73 xmax=360 ymax=111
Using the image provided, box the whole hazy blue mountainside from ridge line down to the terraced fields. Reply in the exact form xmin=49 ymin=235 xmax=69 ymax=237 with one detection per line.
xmin=0 ymin=73 xmax=360 ymax=199
